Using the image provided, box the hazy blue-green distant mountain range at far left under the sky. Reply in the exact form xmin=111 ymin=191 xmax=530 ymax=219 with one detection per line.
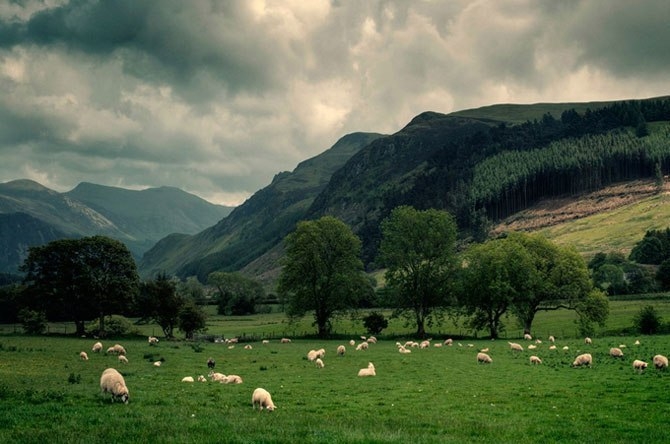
xmin=0 ymin=179 xmax=232 ymax=273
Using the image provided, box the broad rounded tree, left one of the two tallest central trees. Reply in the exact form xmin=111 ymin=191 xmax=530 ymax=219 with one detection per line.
xmin=278 ymin=216 xmax=372 ymax=337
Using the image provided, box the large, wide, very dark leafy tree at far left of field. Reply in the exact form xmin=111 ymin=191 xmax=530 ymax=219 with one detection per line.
xmin=22 ymin=236 xmax=139 ymax=335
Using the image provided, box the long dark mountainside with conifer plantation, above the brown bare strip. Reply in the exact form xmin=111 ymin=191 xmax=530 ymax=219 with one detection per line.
xmin=140 ymin=97 xmax=670 ymax=286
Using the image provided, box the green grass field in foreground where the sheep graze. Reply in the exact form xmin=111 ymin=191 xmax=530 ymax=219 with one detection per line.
xmin=0 ymin=301 xmax=670 ymax=443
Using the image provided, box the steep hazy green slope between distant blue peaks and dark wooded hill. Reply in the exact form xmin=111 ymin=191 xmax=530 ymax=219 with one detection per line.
xmin=139 ymin=133 xmax=381 ymax=280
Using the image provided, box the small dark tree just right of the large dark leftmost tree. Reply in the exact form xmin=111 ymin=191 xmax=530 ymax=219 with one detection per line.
xmin=137 ymin=273 xmax=186 ymax=339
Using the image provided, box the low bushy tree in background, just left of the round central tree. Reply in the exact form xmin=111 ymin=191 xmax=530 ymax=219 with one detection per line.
xmin=207 ymin=271 xmax=265 ymax=316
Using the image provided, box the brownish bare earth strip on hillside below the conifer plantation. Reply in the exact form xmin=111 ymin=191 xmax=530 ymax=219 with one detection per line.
xmin=491 ymin=180 xmax=670 ymax=236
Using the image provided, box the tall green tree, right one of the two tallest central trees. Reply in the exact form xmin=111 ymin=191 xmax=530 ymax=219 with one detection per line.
xmin=379 ymin=206 xmax=456 ymax=337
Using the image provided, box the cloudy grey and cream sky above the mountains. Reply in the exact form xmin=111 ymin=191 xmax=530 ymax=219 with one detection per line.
xmin=0 ymin=0 xmax=670 ymax=205
